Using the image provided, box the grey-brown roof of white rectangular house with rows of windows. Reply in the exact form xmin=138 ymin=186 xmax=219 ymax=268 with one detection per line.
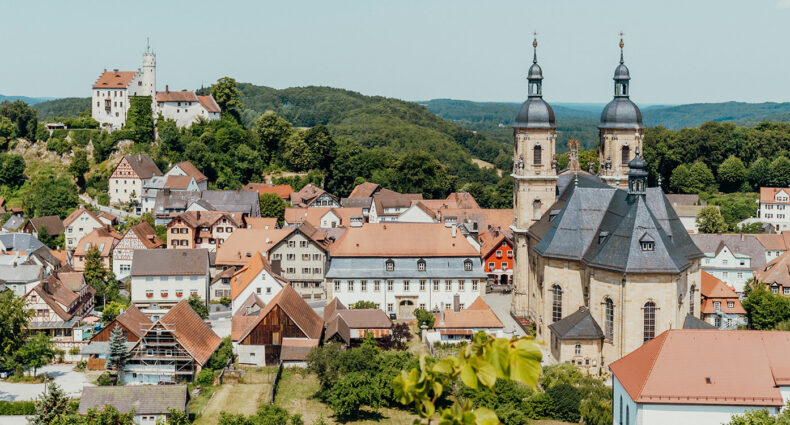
xmin=131 ymin=249 xmax=208 ymax=276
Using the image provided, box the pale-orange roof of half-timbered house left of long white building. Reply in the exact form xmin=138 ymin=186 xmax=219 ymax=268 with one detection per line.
xmin=215 ymin=228 xmax=294 ymax=266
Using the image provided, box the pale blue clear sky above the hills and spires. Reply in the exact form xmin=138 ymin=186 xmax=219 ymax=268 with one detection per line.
xmin=0 ymin=0 xmax=790 ymax=104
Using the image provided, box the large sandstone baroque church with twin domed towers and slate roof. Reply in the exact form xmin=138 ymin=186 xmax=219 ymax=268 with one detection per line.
xmin=511 ymin=39 xmax=703 ymax=372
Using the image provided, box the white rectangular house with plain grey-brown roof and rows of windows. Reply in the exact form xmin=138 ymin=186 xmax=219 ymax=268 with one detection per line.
xmin=131 ymin=249 xmax=210 ymax=317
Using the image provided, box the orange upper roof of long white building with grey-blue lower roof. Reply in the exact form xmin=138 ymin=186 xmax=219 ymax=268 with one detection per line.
xmin=331 ymin=223 xmax=480 ymax=257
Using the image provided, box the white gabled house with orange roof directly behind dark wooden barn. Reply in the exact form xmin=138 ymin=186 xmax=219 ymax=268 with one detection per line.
xmin=230 ymin=252 xmax=288 ymax=314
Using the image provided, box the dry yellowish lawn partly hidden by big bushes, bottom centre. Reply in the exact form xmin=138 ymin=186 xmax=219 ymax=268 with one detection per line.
xmin=275 ymin=369 xmax=417 ymax=425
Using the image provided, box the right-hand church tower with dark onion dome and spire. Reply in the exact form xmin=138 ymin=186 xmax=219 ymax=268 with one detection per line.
xmin=598 ymin=33 xmax=645 ymax=188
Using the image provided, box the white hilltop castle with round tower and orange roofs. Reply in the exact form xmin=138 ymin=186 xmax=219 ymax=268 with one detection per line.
xmin=91 ymin=43 xmax=221 ymax=131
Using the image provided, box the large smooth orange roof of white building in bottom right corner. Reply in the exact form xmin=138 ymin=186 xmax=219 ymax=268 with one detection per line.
xmin=609 ymin=329 xmax=790 ymax=407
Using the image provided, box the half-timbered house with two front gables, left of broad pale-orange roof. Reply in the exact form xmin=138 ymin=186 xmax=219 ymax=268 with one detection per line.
xmin=167 ymin=211 xmax=244 ymax=251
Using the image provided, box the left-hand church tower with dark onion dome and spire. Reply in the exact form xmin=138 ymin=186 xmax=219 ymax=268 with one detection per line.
xmin=511 ymin=35 xmax=557 ymax=315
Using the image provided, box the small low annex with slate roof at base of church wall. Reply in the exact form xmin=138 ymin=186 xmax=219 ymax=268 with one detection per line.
xmin=549 ymin=306 xmax=605 ymax=373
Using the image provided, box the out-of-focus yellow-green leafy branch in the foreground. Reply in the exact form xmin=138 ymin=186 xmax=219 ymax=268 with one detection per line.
xmin=393 ymin=332 xmax=541 ymax=425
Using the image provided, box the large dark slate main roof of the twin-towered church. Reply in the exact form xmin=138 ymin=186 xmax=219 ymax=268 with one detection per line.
xmin=529 ymin=173 xmax=703 ymax=274
